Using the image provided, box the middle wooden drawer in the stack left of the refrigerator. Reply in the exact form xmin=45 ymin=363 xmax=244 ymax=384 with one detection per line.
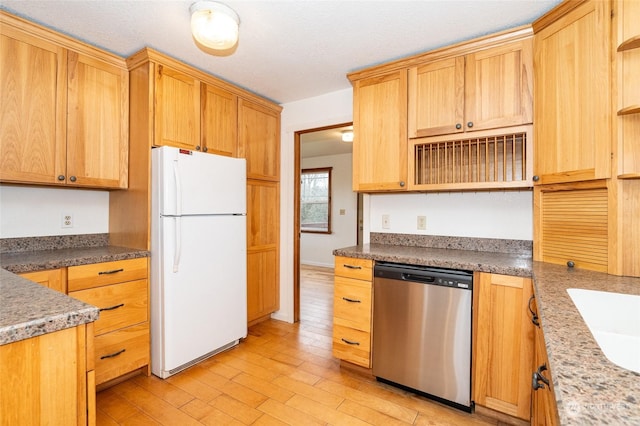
xmin=69 ymin=280 xmax=148 ymax=336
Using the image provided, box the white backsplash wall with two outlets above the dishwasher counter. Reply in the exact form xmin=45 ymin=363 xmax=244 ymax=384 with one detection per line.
xmin=369 ymin=191 xmax=533 ymax=240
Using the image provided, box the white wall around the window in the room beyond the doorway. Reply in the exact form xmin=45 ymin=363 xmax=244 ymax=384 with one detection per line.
xmin=300 ymin=154 xmax=358 ymax=268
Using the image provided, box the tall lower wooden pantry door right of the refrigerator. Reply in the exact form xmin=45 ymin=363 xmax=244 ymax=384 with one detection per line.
xmin=247 ymin=180 xmax=280 ymax=323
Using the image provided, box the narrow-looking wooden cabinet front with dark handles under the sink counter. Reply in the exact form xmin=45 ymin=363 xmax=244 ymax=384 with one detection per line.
xmin=531 ymin=300 xmax=560 ymax=426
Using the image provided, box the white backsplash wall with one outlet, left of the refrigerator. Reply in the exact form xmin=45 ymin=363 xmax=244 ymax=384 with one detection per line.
xmin=0 ymin=185 xmax=109 ymax=238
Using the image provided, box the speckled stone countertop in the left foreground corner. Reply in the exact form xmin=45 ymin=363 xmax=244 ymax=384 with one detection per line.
xmin=0 ymin=270 xmax=98 ymax=345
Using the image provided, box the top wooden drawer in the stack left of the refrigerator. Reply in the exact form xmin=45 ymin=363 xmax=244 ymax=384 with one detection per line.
xmin=67 ymin=257 xmax=147 ymax=292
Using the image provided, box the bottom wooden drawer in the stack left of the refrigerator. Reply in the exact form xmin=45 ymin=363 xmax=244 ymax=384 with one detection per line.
xmin=95 ymin=323 xmax=149 ymax=384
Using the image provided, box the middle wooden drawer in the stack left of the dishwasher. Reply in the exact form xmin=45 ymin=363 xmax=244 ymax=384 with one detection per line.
xmin=333 ymin=276 xmax=371 ymax=332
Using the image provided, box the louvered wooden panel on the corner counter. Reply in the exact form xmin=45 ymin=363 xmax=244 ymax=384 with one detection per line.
xmin=541 ymin=188 xmax=608 ymax=272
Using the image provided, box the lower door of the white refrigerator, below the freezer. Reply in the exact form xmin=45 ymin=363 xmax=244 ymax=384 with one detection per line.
xmin=151 ymin=215 xmax=247 ymax=378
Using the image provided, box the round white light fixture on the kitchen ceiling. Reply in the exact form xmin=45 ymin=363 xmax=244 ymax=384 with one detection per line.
xmin=189 ymin=0 xmax=240 ymax=50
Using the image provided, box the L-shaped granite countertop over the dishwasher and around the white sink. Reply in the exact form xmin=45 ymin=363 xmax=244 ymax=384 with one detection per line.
xmin=333 ymin=243 xmax=640 ymax=425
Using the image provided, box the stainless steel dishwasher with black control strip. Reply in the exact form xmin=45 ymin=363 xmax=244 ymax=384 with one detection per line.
xmin=372 ymin=262 xmax=473 ymax=412
